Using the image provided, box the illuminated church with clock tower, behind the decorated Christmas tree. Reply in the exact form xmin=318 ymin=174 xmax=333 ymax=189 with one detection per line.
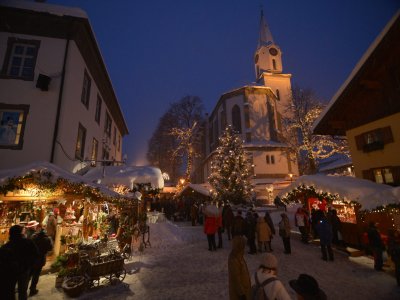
xmin=194 ymin=12 xmax=298 ymax=203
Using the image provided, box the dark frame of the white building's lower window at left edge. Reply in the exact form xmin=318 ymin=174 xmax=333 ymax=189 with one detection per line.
xmin=0 ymin=103 xmax=30 ymax=150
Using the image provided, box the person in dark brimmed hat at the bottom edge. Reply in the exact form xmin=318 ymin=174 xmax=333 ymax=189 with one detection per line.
xmin=289 ymin=274 xmax=327 ymax=300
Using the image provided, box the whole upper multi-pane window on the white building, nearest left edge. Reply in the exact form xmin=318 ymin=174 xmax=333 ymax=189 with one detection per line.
xmin=2 ymin=38 xmax=40 ymax=80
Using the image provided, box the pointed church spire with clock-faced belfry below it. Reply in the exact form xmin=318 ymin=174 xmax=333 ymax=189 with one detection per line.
xmin=254 ymin=9 xmax=282 ymax=80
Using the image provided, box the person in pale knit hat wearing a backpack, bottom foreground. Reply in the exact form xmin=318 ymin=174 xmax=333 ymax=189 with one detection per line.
xmin=251 ymin=253 xmax=291 ymax=300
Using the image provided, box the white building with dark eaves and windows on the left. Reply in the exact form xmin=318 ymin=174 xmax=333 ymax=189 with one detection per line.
xmin=0 ymin=1 xmax=128 ymax=172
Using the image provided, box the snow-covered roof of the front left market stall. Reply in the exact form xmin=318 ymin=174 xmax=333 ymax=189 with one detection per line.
xmin=0 ymin=161 xmax=119 ymax=197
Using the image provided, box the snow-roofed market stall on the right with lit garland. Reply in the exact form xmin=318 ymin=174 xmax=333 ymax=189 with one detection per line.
xmin=279 ymin=175 xmax=400 ymax=248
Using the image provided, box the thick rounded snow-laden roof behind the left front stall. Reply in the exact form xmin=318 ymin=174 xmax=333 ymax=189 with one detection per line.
xmin=84 ymin=166 xmax=164 ymax=189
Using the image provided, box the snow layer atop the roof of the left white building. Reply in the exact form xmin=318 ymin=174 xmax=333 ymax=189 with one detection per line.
xmin=0 ymin=0 xmax=88 ymax=19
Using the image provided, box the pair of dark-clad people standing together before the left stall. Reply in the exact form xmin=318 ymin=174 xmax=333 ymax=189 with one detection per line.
xmin=0 ymin=221 xmax=53 ymax=300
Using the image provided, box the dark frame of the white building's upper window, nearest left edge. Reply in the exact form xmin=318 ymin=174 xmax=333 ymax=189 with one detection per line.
xmin=1 ymin=37 xmax=40 ymax=81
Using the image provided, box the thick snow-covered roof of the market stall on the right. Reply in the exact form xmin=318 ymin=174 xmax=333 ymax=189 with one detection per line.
xmin=278 ymin=175 xmax=400 ymax=209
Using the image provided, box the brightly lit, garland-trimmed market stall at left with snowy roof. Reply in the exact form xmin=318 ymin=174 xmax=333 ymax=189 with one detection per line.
xmin=0 ymin=162 xmax=120 ymax=256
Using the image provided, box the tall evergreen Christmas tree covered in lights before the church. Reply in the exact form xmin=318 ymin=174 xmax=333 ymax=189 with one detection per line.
xmin=208 ymin=126 xmax=251 ymax=204
